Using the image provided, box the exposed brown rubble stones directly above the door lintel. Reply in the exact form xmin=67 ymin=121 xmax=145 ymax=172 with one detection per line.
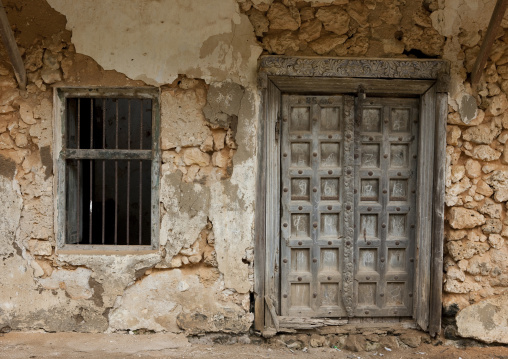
xmin=239 ymin=0 xmax=445 ymax=57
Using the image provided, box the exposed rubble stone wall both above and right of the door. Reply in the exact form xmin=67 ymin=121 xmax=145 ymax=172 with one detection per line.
xmin=238 ymin=0 xmax=508 ymax=343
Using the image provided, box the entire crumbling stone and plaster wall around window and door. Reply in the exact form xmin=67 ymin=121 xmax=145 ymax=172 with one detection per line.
xmin=0 ymin=0 xmax=508 ymax=343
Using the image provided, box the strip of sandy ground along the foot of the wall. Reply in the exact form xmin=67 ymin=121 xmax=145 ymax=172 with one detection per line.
xmin=0 ymin=332 xmax=508 ymax=359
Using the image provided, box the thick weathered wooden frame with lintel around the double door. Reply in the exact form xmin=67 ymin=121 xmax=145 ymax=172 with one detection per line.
xmin=254 ymin=56 xmax=449 ymax=335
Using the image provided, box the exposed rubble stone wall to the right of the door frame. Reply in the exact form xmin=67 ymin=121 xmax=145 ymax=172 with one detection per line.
xmin=443 ymin=23 xmax=508 ymax=343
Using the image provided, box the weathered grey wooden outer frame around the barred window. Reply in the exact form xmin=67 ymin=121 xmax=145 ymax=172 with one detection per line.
xmin=53 ymin=87 xmax=161 ymax=254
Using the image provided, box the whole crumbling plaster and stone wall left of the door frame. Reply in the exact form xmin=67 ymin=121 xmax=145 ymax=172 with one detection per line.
xmin=0 ymin=0 xmax=261 ymax=334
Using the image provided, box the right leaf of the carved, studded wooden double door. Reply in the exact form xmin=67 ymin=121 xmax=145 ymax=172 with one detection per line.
xmin=354 ymin=98 xmax=419 ymax=317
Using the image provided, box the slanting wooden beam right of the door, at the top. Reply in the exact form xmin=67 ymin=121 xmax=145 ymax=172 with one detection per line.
xmin=471 ymin=0 xmax=508 ymax=86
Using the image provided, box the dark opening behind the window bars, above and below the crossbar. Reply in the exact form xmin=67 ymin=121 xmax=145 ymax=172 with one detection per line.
xmin=66 ymin=98 xmax=152 ymax=245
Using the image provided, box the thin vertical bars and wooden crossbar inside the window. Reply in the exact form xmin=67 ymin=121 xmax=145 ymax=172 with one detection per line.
xmin=62 ymin=98 xmax=153 ymax=245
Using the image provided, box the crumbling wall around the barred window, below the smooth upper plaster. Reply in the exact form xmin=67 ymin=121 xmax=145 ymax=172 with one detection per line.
xmin=0 ymin=0 xmax=256 ymax=334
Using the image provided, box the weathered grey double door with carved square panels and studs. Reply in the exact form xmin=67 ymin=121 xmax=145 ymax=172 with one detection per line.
xmin=280 ymin=95 xmax=418 ymax=317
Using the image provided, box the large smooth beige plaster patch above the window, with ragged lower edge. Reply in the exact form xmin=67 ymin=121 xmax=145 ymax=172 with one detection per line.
xmin=48 ymin=0 xmax=261 ymax=86
